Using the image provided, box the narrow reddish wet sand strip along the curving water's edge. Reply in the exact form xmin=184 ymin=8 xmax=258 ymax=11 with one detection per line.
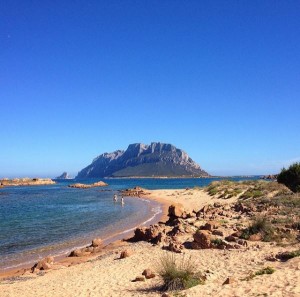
xmin=0 ymin=195 xmax=170 ymax=280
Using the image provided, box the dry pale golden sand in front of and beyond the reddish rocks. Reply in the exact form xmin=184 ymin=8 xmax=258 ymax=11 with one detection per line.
xmin=0 ymin=190 xmax=300 ymax=297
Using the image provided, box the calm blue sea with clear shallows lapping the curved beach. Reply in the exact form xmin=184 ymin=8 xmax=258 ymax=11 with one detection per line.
xmin=0 ymin=176 xmax=259 ymax=271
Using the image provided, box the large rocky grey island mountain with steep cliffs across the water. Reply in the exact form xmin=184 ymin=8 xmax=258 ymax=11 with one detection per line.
xmin=76 ymin=142 xmax=210 ymax=178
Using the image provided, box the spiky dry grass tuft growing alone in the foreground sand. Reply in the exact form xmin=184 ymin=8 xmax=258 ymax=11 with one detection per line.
xmin=158 ymin=253 xmax=205 ymax=291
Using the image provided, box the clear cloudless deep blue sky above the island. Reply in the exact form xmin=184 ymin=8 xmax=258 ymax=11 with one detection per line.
xmin=0 ymin=0 xmax=300 ymax=177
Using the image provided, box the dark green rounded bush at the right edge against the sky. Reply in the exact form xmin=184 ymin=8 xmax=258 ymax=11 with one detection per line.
xmin=277 ymin=163 xmax=300 ymax=192
